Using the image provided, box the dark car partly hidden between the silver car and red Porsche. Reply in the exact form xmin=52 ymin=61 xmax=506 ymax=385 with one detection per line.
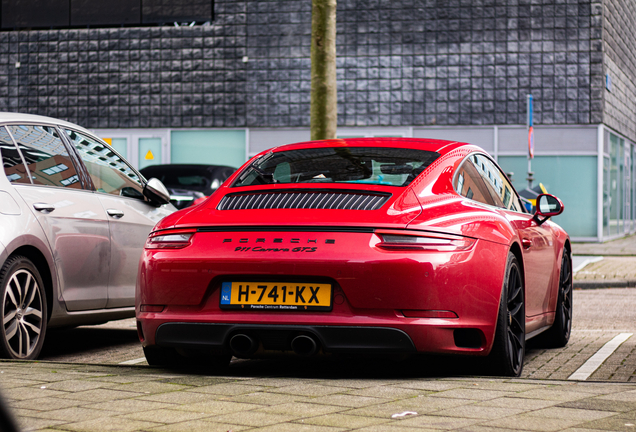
xmin=140 ymin=164 xmax=236 ymax=209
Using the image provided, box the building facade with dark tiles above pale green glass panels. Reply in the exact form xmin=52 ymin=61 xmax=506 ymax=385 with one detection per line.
xmin=0 ymin=0 xmax=636 ymax=240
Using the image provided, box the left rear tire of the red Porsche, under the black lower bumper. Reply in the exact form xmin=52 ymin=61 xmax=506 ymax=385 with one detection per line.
xmin=144 ymin=346 xmax=232 ymax=373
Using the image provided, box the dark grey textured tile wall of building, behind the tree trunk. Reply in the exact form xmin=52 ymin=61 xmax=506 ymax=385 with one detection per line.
xmin=0 ymin=0 xmax=612 ymax=136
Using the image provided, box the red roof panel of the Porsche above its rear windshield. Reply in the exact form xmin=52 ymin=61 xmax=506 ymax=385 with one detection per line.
xmin=264 ymin=137 xmax=468 ymax=155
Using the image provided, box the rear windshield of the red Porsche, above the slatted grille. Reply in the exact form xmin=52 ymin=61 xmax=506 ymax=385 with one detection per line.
xmin=233 ymin=147 xmax=439 ymax=187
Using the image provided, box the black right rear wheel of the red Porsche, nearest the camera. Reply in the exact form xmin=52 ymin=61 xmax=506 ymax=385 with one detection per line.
xmin=489 ymin=252 xmax=526 ymax=377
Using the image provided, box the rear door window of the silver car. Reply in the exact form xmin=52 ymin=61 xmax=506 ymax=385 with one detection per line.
xmin=3 ymin=125 xmax=82 ymax=189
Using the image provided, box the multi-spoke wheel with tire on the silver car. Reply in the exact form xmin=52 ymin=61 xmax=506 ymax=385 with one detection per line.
xmin=0 ymin=256 xmax=48 ymax=360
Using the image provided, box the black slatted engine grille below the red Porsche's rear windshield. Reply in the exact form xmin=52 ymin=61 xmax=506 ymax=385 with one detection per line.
xmin=217 ymin=191 xmax=391 ymax=210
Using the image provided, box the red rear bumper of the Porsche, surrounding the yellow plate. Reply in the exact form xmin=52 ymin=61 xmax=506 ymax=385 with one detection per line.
xmin=136 ymin=232 xmax=507 ymax=355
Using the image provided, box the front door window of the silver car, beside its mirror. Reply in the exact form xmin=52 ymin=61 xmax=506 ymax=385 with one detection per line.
xmin=65 ymin=129 xmax=143 ymax=199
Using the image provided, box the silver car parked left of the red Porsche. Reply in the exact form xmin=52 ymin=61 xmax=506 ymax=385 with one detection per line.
xmin=0 ymin=113 xmax=175 ymax=359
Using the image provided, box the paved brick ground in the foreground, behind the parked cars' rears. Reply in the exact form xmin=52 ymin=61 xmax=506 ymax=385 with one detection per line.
xmin=0 ymin=362 xmax=636 ymax=432
